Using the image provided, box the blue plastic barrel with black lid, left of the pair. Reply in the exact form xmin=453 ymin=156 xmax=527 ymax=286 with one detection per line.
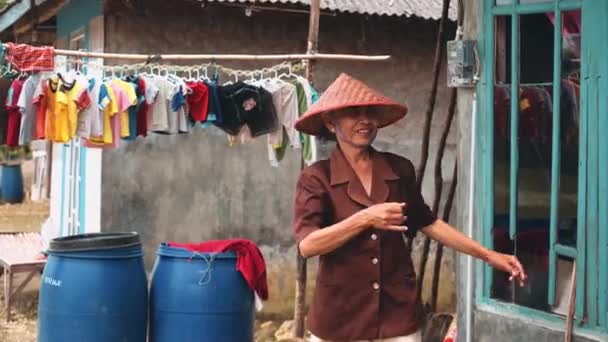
xmin=38 ymin=233 xmax=148 ymax=342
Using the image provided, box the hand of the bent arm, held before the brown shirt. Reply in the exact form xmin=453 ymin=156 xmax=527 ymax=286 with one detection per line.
xmin=359 ymin=202 xmax=407 ymax=232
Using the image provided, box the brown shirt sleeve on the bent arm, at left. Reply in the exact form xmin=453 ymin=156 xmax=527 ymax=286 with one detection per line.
xmin=293 ymin=172 xmax=329 ymax=243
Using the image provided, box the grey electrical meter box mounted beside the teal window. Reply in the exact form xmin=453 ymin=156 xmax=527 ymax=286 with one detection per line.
xmin=447 ymin=40 xmax=476 ymax=87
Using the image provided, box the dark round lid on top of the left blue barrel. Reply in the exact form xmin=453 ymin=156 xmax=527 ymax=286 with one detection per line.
xmin=48 ymin=232 xmax=141 ymax=253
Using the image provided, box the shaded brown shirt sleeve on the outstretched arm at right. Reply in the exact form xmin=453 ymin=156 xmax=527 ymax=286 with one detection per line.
xmin=406 ymin=160 xmax=437 ymax=238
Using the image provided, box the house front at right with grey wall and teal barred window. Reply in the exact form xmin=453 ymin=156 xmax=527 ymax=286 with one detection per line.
xmin=456 ymin=0 xmax=608 ymax=341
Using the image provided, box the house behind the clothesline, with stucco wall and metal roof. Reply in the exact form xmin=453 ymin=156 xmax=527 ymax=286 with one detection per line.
xmin=0 ymin=0 xmax=456 ymax=315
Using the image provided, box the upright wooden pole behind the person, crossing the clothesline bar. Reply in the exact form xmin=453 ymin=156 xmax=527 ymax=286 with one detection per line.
xmin=293 ymin=0 xmax=321 ymax=338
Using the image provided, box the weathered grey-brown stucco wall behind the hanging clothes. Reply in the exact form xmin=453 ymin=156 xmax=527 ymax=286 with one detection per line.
xmin=102 ymin=1 xmax=456 ymax=320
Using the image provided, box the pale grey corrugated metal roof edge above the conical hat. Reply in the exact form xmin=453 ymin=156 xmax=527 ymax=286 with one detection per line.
xmin=207 ymin=0 xmax=457 ymax=20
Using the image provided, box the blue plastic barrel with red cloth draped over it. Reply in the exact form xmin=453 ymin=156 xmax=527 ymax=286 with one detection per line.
xmin=149 ymin=244 xmax=255 ymax=342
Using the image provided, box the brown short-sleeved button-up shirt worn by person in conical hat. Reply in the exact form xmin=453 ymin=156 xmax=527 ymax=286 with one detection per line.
xmin=294 ymin=148 xmax=436 ymax=341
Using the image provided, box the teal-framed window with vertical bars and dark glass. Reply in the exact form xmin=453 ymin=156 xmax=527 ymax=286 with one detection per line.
xmin=482 ymin=0 xmax=608 ymax=329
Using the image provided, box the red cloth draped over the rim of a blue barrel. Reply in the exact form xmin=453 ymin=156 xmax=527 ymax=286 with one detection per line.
xmin=168 ymin=239 xmax=268 ymax=300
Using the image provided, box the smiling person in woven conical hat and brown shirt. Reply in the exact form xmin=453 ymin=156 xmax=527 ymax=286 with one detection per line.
xmin=294 ymin=74 xmax=526 ymax=342
